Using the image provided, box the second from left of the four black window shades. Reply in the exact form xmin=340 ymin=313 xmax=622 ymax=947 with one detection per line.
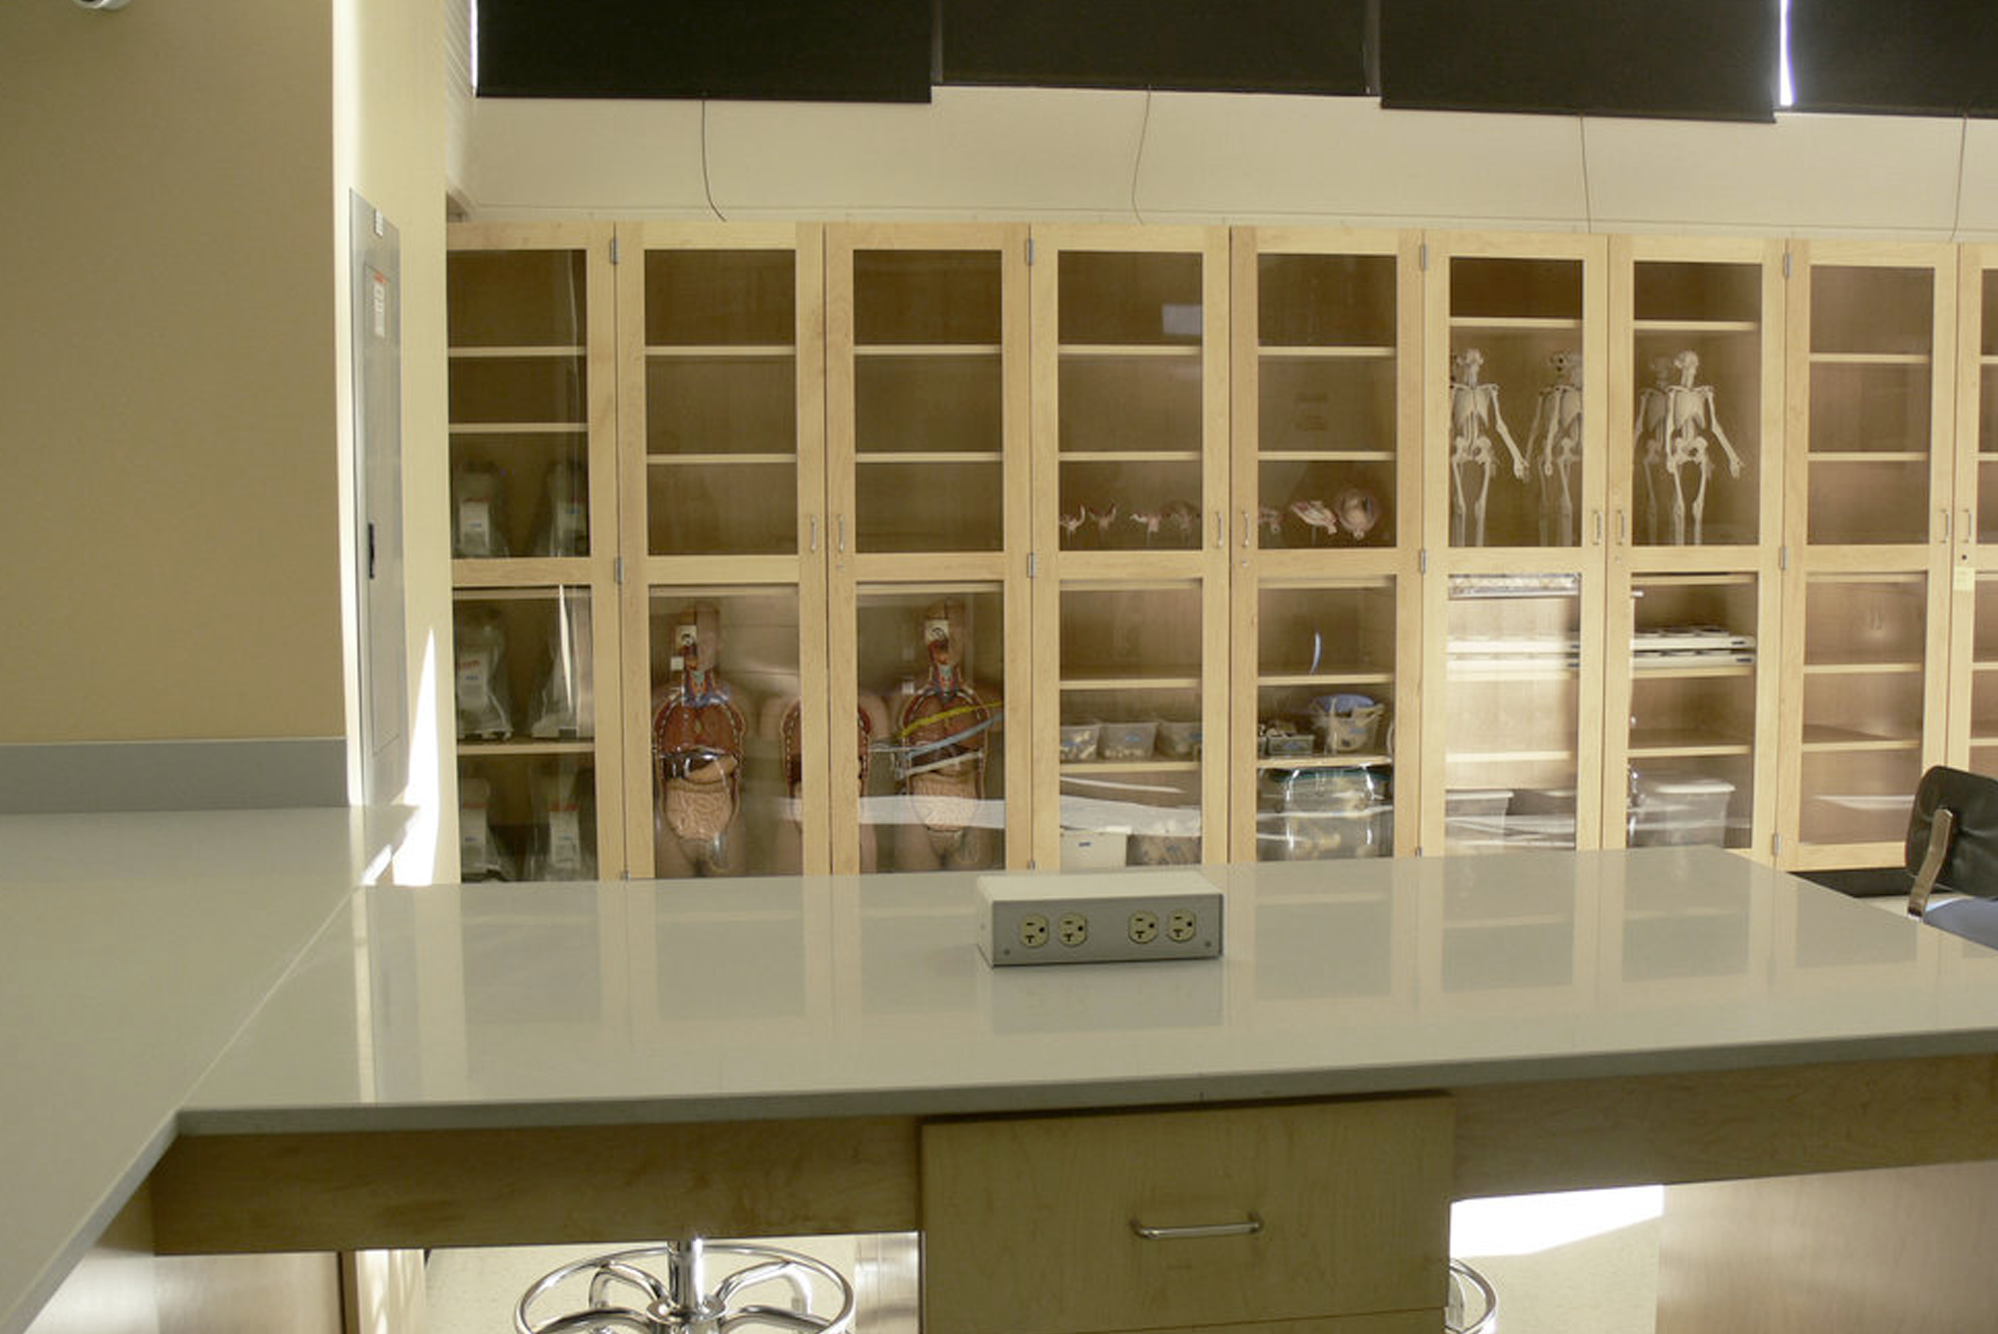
xmin=941 ymin=0 xmax=1369 ymax=94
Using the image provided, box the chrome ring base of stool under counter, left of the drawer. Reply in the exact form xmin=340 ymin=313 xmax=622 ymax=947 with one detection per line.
xmin=513 ymin=1238 xmax=853 ymax=1334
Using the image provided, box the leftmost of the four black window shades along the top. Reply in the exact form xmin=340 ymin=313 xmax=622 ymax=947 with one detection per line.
xmin=478 ymin=0 xmax=933 ymax=102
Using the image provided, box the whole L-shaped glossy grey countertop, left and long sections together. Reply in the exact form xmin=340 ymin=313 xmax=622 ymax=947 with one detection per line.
xmin=11 ymin=838 xmax=1998 ymax=1334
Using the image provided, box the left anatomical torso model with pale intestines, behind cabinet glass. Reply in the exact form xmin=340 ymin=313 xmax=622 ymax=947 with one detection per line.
xmin=651 ymin=603 xmax=747 ymax=877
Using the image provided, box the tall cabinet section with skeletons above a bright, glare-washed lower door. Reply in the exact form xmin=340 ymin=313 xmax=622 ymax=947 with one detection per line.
xmin=1421 ymin=236 xmax=1608 ymax=853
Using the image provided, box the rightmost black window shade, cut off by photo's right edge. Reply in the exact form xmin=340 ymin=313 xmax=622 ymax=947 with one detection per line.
xmin=1790 ymin=0 xmax=1998 ymax=116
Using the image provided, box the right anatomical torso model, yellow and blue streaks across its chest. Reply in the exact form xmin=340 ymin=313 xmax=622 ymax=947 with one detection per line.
xmin=893 ymin=601 xmax=999 ymax=871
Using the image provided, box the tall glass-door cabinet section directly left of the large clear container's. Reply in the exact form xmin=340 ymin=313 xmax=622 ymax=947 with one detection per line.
xmin=1033 ymin=228 xmax=1229 ymax=869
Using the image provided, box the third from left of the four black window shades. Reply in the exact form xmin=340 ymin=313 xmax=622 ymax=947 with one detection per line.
xmin=1381 ymin=0 xmax=1782 ymax=120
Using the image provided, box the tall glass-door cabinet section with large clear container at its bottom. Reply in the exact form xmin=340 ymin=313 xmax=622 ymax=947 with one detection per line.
xmin=1227 ymin=228 xmax=1421 ymax=861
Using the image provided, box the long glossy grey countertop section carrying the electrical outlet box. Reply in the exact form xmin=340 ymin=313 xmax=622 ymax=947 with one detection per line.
xmin=194 ymin=849 xmax=1998 ymax=1132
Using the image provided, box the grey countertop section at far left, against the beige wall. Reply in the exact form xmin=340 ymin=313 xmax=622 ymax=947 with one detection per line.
xmin=0 ymin=809 xmax=402 ymax=1334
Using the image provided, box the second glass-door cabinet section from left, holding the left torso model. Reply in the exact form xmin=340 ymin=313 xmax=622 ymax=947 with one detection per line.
xmin=617 ymin=224 xmax=829 ymax=879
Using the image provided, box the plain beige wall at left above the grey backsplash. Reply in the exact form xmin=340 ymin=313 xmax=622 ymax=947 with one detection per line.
xmin=0 ymin=0 xmax=342 ymax=741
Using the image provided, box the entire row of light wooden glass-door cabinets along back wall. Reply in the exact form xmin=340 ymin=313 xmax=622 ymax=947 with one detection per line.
xmin=448 ymin=224 xmax=1998 ymax=875
